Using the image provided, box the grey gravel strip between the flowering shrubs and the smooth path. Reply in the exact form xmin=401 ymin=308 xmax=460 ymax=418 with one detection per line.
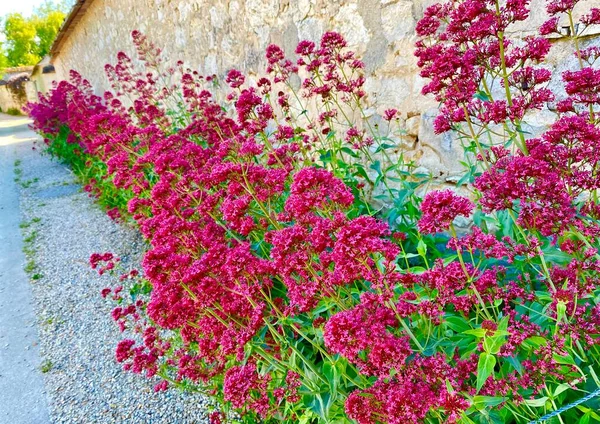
xmin=8 ymin=114 xmax=208 ymax=424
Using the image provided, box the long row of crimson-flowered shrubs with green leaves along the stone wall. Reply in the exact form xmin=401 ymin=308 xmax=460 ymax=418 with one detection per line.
xmin=29 ymin=0 xmax=600 ymax=423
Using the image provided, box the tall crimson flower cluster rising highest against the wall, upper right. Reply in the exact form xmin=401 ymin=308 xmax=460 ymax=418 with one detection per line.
xmin=415 ymin=0 xmax=554 ymax=133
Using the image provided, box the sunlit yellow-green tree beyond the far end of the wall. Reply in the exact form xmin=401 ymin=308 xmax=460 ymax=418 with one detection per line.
xmin=0 ymin=0 xmax=72 ymax=69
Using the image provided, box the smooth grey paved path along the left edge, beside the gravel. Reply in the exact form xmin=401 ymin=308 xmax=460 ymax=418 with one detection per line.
xmin=0 ymin=114 xmax=50 ymax=424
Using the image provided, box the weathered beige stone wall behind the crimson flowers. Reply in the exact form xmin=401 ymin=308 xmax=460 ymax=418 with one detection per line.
xmin=53 ymin=0 xmax=599 ymax=180
